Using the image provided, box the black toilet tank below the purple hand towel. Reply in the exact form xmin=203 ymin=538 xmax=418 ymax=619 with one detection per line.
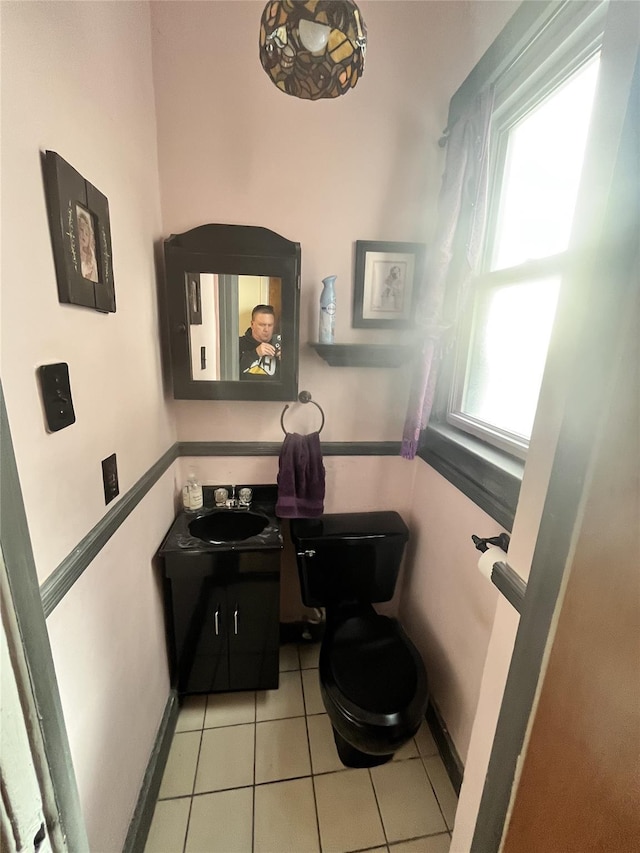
xmin=291 ymin=512 xmax=409 ymax=607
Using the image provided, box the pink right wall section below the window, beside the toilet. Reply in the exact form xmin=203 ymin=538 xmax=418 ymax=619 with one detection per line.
xmin=400 ymin=462 xmax=502 ymax=761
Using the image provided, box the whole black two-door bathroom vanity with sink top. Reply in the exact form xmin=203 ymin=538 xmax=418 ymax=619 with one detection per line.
xmin=158 ymin=486 xmax=282 ymax=694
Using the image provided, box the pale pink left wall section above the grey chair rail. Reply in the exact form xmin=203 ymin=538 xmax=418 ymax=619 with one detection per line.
xmin=1 ymin=2 xmax=174 ymax=581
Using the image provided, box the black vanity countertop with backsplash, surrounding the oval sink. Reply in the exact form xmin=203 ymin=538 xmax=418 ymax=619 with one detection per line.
xmin=158 ymin=484 xmax=282 ymax=557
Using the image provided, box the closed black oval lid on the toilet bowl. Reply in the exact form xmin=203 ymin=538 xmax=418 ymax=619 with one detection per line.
xmin=330 ymin=615 xmax=416 ymax=714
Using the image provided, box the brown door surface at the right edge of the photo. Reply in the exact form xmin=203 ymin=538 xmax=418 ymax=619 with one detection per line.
xmin=503 ymin=258 xmax=640 ymax=853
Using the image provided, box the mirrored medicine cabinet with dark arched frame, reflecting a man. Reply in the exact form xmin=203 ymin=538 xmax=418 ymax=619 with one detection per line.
xmin=165 ymin=225 xmax=300 ymax=400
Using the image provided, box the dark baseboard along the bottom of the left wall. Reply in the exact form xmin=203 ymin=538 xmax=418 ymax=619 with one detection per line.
xmin=122 ymin=690 xmax=179 ymax=853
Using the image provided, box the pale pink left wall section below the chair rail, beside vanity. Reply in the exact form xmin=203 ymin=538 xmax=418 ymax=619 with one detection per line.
xmin=47 ymin=471 xmax=175 ymax=853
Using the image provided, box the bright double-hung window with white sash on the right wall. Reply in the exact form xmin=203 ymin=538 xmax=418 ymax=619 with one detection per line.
xmin=447 ymin=55 xmax=598 ymax=456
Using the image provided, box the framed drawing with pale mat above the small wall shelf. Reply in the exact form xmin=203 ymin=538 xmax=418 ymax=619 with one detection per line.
xmin=352 ymin=240 xmax=425 ymax=329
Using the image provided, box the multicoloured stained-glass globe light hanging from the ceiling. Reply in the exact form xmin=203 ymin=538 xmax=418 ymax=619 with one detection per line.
xmin=260 ymin=0 xmax=367 ymax=101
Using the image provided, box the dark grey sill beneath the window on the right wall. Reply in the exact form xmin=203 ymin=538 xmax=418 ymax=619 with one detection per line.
xmin=418 ymin=423 xmax=524 ymax=531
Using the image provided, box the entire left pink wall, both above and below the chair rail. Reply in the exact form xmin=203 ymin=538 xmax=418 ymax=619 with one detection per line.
xmin=1 ymin=2 xmax=175 ymax=853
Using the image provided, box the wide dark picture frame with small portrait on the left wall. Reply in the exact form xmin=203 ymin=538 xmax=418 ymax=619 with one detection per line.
xmin=43 ymin=151 xmax=116 ymax=312
